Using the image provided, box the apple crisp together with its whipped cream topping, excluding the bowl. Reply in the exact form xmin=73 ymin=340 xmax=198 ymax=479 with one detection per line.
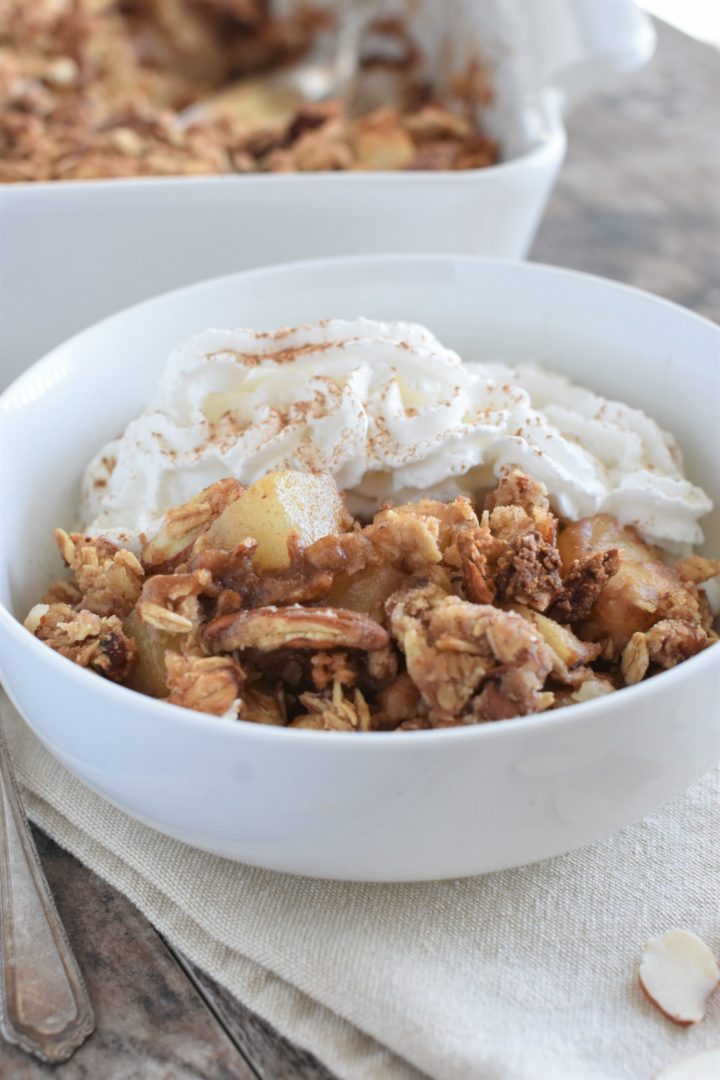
xmin=25 ymin=319 xmax=720 ymax=732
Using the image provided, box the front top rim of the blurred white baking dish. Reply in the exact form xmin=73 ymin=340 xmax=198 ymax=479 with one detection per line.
xmin=0 ymin=89 xmax=568 ymax=195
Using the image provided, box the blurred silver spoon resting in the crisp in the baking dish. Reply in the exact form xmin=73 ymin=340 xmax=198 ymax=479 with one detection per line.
xmin=177 ymin=0 xmax=382 ymax=129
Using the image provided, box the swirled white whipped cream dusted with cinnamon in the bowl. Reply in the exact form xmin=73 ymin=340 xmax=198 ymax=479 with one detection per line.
xmin=82 ymin=319 xmax=711 ymax=552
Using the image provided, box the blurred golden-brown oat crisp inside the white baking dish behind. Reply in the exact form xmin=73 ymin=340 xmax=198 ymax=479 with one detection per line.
xmin=0 ymin=0 xmax=498 ymax=183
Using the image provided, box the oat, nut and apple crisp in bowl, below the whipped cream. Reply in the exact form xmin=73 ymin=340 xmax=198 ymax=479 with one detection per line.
xmin=26 ymin=469 xmax=720 ymax=731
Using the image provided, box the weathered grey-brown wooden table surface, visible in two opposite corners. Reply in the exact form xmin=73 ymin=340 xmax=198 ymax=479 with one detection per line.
xmin=0 ymin=16 xmax=720 ymax=1080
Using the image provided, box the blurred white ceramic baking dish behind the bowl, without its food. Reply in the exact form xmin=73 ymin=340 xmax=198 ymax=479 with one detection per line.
xmin=0 ymin=0 xmax=654 ymax=388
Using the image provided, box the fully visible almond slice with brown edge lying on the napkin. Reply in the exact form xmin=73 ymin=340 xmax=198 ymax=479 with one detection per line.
xmin=640 ymin=930 xmax=720 ymax=1024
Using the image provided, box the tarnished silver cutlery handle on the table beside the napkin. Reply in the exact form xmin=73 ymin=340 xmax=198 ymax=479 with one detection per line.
xmin=0 ymin=733 xmax=95 ymax=1063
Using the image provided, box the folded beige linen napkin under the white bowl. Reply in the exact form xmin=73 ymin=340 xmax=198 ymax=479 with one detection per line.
xmin=0 ymin=699 xmax=720 ymax=1080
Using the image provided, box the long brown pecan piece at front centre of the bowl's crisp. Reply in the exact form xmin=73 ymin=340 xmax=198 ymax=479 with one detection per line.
xmin=204 ymin=607 xmax=390 ymax=652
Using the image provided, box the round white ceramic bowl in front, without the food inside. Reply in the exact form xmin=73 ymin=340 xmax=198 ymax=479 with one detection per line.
xmin=0 ymin=256 xmax=720 ymax=880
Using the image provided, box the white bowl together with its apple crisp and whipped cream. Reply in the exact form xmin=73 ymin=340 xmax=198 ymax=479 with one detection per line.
xmin=0 ymin=256 xmax=720 ymax=881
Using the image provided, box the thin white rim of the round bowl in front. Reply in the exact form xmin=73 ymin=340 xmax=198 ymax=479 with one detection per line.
xmin=0 ymin=253 xmax=720 ymax=753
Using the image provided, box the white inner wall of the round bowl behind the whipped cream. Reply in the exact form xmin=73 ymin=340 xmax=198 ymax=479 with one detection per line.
xmin=0 ymin=256 xmax=720 ymax=617
